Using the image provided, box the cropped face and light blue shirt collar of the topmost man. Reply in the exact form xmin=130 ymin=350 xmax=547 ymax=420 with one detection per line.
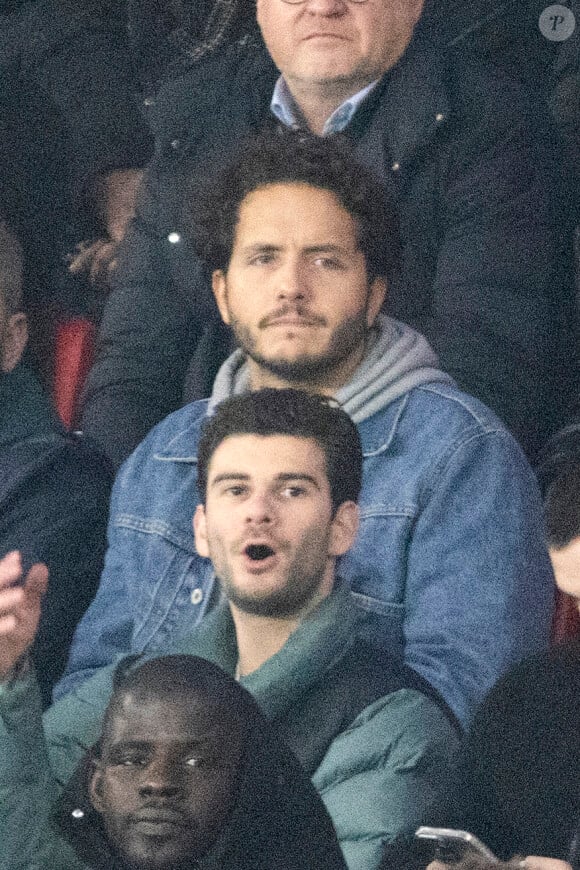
xmin=257 ymin=0 xmax=423 ymax=136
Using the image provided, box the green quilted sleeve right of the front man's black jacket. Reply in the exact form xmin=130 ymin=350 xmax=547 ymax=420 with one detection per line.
xmin=313 ymin=689 xmax=459 ymax=870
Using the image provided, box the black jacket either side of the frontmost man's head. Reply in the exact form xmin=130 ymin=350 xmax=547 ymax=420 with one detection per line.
xmin=54 ymin=726 xmax=346 ymax=870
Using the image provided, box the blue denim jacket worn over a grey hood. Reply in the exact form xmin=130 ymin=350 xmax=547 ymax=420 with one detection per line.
xmin=56 ymin=383 xmax=554 ymax=724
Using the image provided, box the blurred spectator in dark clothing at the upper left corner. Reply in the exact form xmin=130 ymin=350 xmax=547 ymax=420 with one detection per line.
xmin=0 ymin=0 xmax=152 ymax=382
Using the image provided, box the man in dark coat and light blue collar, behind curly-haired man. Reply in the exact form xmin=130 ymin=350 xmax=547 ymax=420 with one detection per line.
xmin=83 ymin=0 xmax=575 ymax=463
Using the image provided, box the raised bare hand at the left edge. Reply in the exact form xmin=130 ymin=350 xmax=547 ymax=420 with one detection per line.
xmin=0 ymin=551 xmax=48 ymax=680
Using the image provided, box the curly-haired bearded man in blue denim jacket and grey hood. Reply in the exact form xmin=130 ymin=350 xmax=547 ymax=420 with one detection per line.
xmin=57 ymin=133 xmax=553 ymax=723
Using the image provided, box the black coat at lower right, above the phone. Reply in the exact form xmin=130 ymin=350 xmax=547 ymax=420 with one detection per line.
xmin=428 ymin=641 xmax=580 ymax=866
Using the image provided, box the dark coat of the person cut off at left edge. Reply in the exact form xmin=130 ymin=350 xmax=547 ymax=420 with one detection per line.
xmin=0 ymin=367 xmax=111 ymax=701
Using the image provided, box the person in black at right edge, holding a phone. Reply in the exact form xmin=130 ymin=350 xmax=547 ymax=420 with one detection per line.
xmin=384 ymin=425 xmax=580 ymax=870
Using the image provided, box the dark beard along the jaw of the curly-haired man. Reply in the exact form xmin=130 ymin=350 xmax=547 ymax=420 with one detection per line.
xmin=230 ymin=311 xmax=368 ymax=384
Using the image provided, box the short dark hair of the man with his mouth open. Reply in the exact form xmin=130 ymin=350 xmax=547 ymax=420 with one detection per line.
xmin=197 ymin=389 xmax=362 ymax=511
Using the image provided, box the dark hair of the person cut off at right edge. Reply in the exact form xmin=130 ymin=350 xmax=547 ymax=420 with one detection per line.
xmin=538 ymin=424 xmax=580 ymax=550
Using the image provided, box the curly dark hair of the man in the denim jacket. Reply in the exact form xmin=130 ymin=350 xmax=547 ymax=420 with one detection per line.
xmin=190 ymin=129 xmax=400 ymax=280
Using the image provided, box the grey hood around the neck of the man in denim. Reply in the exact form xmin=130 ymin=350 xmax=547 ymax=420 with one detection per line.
xmin=209 ymin=314 xmax=454 ymax=423
